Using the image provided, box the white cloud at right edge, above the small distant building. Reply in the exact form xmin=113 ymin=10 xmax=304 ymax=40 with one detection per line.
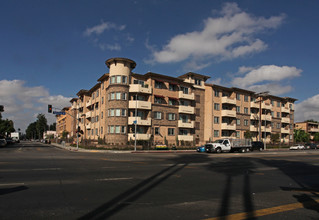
xmin=295 ymin=94 xmax=319 ymax=122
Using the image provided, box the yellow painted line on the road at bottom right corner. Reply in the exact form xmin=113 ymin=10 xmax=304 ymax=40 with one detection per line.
xmin=205 ymin=199 xmax=319 ymax=220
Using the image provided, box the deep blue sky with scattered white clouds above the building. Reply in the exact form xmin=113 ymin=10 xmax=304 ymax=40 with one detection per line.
xmin=0 ymin=0 xmax=319 ymax=132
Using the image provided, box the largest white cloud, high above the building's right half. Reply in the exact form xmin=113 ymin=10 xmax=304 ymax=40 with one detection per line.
xmin=152 ymin=3 xmax=285 ymax=63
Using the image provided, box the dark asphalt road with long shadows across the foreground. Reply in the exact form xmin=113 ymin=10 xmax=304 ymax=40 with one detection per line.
xmin=0 ymin=142 xmax=319 ymax=220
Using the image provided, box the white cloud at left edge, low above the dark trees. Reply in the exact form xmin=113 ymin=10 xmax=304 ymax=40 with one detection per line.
xmin=0 ymin=80 xmax=71 ymax=132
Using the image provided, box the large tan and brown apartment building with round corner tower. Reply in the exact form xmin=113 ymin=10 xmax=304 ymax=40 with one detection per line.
xmin=58 ymin=58 xmax=296 ymax=145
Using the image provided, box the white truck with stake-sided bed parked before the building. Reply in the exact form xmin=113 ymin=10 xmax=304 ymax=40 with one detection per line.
xmin=205 ymin=139 xmax=252 ymax=153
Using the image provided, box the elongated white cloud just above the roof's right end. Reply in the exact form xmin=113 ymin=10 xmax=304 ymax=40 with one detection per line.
xmin=232 ymin=65 xmax=302 ymax=88
